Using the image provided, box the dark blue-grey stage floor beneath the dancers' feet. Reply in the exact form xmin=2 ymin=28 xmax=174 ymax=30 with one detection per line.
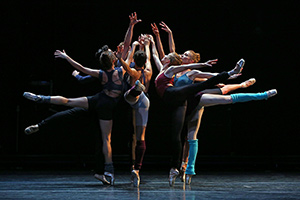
xmin=0 ymin=170 xmax=300 ymax=200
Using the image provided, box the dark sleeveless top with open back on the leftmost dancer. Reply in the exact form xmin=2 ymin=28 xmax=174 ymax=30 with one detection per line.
xmin=99 ymin=67 xmax=124 ymax=92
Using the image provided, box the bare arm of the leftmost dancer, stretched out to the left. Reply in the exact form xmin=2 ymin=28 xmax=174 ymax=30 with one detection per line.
xmin=54 ymin=50 xmax=99 ymax=77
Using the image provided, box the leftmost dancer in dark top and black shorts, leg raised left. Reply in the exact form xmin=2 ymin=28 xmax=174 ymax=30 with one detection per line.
xmin=24 ymin=46 xmax=126 ymax=185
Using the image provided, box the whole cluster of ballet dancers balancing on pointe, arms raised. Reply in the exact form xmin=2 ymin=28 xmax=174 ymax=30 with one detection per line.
xmin=23 ymin=13 xmax=277 ymax=187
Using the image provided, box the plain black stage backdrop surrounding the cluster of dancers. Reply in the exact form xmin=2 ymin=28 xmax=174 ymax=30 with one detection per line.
xmin=0 ymin=0 xmax=300 ymax=168
